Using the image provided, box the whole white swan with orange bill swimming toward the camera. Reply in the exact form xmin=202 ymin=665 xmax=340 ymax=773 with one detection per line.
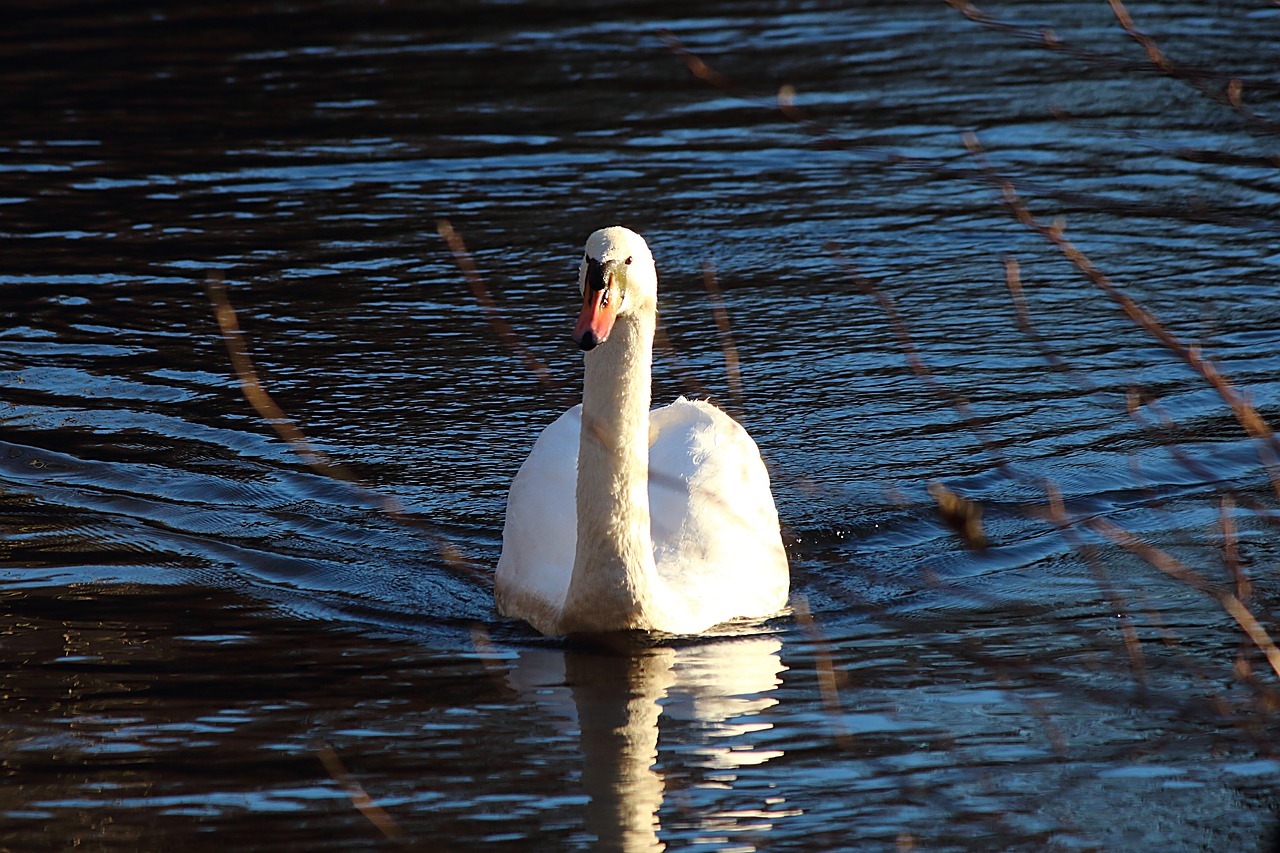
xmin=494 ymin=227 xmax=790 ymax=637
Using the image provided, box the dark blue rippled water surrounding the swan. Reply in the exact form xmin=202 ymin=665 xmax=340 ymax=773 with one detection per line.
xmin=0 ymin=1 xmax=1280 ymax=850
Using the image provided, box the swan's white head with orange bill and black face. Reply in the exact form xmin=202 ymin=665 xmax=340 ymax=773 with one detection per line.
xmin=573 ymin=225 xmax=658 ymax=350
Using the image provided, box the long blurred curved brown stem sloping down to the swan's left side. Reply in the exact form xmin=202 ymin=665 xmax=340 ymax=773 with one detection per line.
xmin=205 ymin=270 xmax=493 ymax=587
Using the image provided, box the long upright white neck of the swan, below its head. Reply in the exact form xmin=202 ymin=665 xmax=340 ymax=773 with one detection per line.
xmin=563 ymin=313 xmax=657 ymax=633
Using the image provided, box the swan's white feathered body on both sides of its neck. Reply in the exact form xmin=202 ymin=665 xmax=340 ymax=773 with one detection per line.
xmin=497 ymin=397 xmax=790 ymax=634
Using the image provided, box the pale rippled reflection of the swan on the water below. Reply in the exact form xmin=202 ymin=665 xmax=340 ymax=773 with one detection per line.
xmin=509 ymin=637 xmax=786 ymax=853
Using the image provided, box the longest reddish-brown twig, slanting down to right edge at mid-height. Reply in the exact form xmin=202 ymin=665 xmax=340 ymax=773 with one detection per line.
xmin=964 ymin=132 xmax=1280 ymax=496
